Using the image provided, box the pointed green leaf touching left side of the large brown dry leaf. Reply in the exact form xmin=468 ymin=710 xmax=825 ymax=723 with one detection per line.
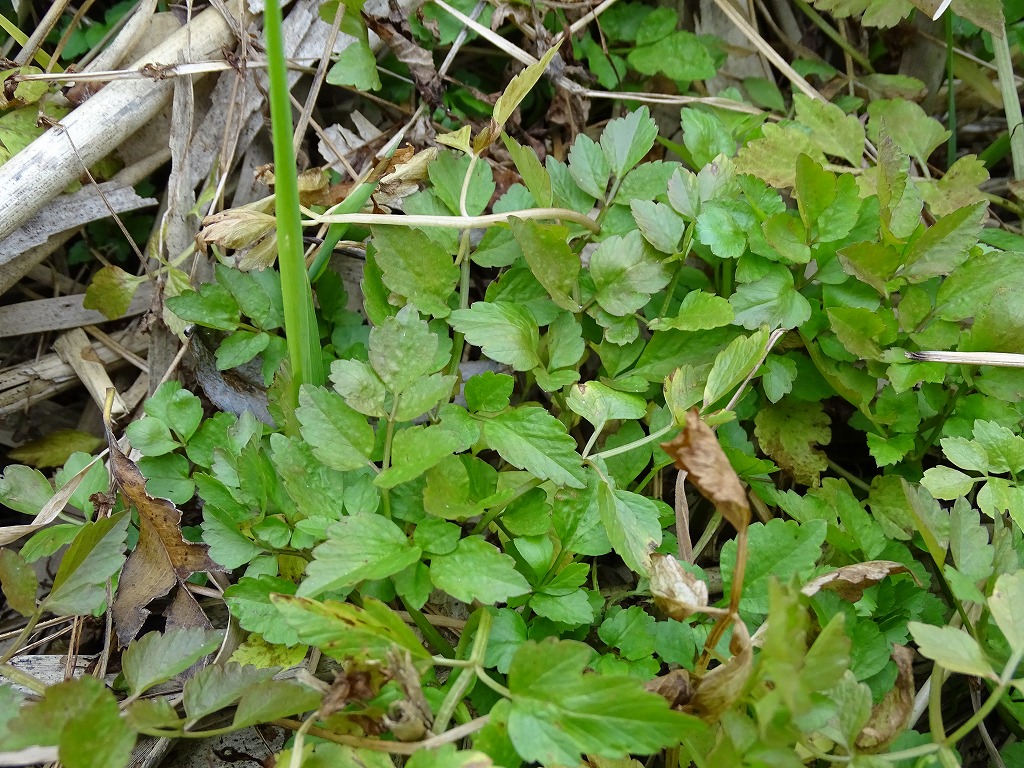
xmin=41 ymin=512 xmax=129 ymax=616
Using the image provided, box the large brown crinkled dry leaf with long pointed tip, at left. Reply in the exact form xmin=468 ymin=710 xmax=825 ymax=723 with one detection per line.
xmin=104 ymin=393 xmax=223 ymax=647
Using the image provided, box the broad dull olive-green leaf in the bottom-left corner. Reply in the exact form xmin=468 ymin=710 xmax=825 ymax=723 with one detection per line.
xmin=4 ymin=675 xmax=135 ymax=768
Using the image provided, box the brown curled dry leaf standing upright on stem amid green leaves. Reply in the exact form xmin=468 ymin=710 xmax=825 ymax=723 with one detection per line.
xmin=662 ymin=410 xmax=751 ymax=530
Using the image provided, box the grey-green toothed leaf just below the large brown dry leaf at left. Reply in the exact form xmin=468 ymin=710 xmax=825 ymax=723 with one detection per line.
xmin=121 ymin=628 xmax=221 ymax=696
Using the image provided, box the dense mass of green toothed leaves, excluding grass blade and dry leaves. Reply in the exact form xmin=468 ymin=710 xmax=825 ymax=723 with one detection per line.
xmin=6 ymin=34 xmax=1024 ymax=768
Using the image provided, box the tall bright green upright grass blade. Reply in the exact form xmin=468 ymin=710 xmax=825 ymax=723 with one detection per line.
xmin=263 ymin=0 xmax=324 ymax=402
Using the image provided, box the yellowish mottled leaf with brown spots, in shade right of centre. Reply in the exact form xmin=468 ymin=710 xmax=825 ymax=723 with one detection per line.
xmin=754 ymin=399 xmax=831 ymax=485
